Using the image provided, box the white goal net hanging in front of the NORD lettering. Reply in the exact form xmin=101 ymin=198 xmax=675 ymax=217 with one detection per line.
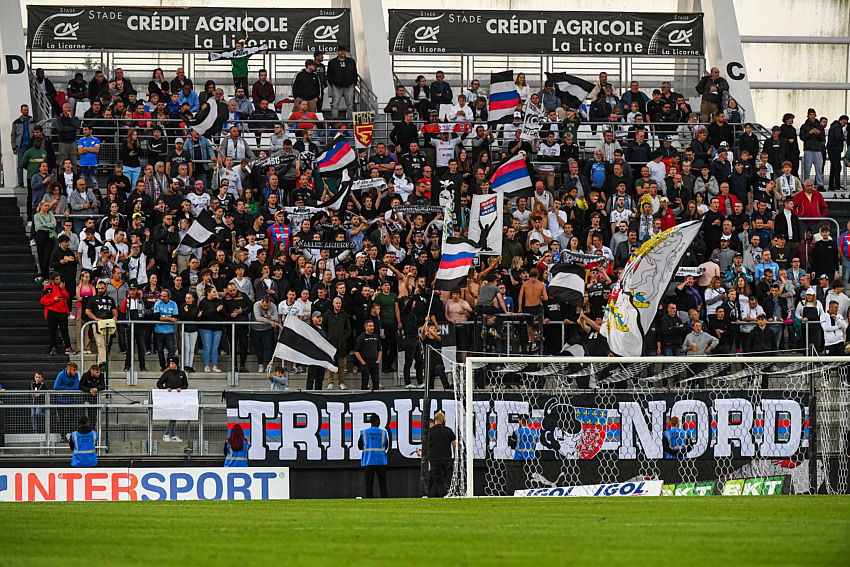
xmin=450 ymin=356 xmax=850 ymax=496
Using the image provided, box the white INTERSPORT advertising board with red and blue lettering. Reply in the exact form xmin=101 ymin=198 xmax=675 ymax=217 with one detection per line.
xmin=0 ymin=467 xmax=289 ymax=502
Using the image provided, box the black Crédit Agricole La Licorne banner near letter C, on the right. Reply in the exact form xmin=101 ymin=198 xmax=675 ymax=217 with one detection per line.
xmin=389 ymin=10 xmax=705 ymax=57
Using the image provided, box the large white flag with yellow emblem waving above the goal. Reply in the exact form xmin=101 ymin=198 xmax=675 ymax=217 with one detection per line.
xmin=600 ymin=220 xmax=702 ymax=356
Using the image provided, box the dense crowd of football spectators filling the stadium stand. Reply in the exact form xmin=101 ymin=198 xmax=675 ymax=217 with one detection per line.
xmin=11 ymin=61 xmax=850 ymax=388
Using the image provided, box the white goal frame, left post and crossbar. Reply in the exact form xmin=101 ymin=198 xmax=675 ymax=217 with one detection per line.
xmin=464 ymin=355 xmax=850 ymax=497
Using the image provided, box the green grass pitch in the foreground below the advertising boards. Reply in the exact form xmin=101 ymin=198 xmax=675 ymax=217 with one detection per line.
xmin=0 ymin=496 xmax=850 ymax=567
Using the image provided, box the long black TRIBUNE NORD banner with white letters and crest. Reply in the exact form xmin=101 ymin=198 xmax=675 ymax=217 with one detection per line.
xmin=225 ymin=390 xmax=809 ymax=467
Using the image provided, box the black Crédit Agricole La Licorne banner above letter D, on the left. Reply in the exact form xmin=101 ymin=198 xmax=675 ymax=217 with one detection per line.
xmin=27 ymin=6 xmax=351 ymax=52
